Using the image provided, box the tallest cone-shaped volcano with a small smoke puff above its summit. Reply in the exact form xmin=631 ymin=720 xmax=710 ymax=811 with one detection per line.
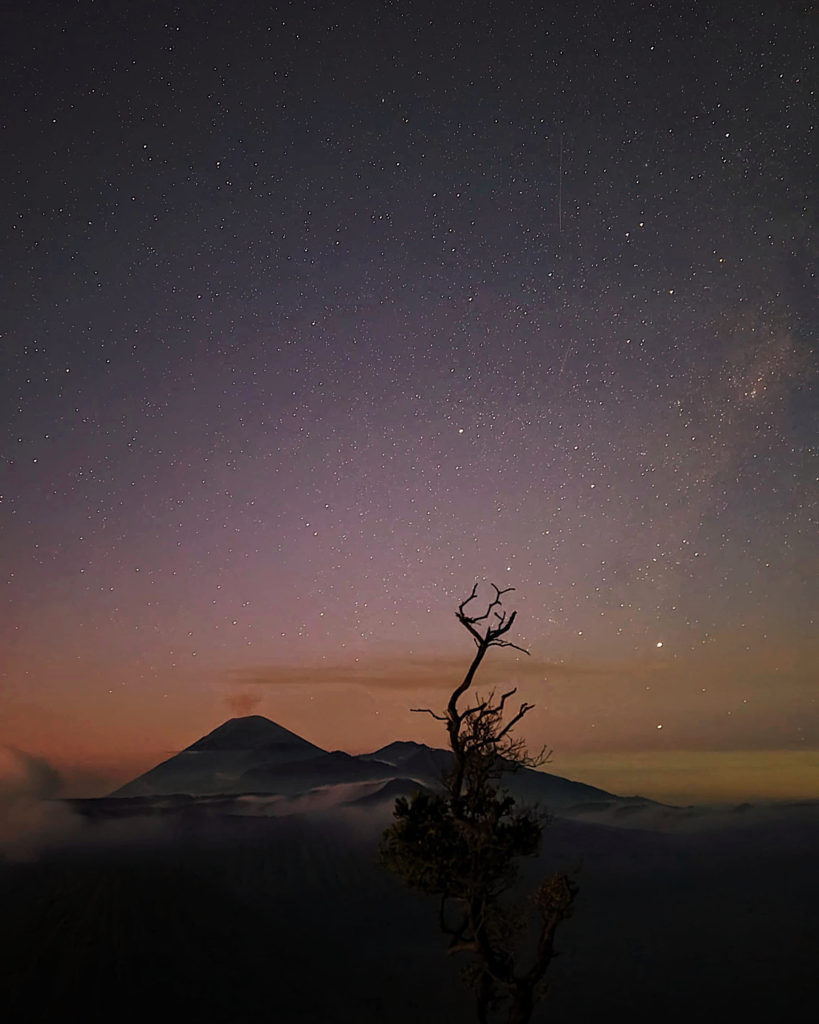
xmin=112 ymin=715 xmax=328 ymax=797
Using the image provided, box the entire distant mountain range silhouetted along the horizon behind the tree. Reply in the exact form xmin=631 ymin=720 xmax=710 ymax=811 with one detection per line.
xmin=111 ymin=715 xmax=652 ymax=813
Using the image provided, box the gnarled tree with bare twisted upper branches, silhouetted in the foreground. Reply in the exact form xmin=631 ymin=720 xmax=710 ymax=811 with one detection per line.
xmin=380 ymin=584 xmax=577 ymax=1024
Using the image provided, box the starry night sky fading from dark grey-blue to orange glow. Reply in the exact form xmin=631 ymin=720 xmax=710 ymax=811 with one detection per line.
xmin=0 ymin=0 xmax=819 ymax=797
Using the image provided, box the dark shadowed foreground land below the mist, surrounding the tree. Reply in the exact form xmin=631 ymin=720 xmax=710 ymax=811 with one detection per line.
xmin=0 ymin=808 xmax=819 ymax=1024
